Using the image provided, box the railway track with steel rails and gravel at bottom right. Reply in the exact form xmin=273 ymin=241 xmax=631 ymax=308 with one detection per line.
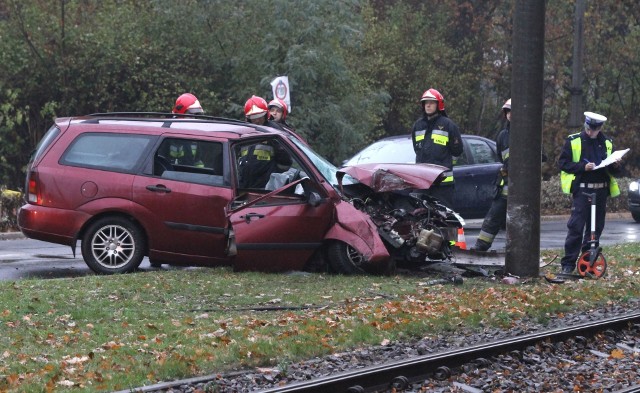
xmin=122 ymin=312 xmax=640 ymax=393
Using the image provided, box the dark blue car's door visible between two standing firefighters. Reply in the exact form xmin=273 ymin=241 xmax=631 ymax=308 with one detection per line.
xmin=453 ymin=135 xmax=502 ymax=219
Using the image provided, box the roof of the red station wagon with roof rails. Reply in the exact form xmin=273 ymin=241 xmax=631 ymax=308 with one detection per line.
xmin=55 ymin=112 xmax=283 ymax=139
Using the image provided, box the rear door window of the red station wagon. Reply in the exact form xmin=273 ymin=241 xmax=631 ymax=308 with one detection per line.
xmin=153 ymin=138 xmax=228 ymax=186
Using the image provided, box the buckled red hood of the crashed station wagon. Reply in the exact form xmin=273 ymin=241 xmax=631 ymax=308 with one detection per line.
xmin=336 ymin=164 xmax=448 ymax=192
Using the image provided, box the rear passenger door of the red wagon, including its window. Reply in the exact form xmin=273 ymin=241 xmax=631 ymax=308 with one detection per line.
xmin=133 ymin=137 xmax=233 ymax=264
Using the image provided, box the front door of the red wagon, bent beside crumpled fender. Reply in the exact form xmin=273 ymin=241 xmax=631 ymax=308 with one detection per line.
xmin=229 ymin=139 xmax=335 ymax=272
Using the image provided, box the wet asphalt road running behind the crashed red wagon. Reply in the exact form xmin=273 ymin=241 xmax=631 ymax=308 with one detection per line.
xmin=0 ymin=215 xmax=640 ymax=280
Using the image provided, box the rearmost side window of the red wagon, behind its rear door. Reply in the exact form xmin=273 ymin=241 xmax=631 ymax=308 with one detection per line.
xmin=60 ymin=133 xmax=153 ymax=172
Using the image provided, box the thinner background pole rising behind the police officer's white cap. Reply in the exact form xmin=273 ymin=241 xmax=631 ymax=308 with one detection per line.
xmin=567 ymin=0 xmax=585 ymax=128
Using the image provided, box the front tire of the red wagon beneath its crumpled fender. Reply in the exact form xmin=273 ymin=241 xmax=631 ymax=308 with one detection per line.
xmin=327 ymin=241 xmax=395 ymax=276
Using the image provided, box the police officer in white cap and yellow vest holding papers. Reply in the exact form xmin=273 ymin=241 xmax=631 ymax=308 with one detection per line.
xmin=558 ymin=112 xmax=621 ymax=274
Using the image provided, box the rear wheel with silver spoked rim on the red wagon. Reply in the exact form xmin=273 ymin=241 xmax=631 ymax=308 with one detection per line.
xmin=82 ymin=217 xmax=145 ymax=274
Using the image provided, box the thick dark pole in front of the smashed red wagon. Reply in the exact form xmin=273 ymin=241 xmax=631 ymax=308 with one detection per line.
xmin=505 ymin=0 xmax=545 ymax=277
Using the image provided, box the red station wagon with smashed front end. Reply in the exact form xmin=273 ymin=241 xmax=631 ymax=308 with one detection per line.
xmin=18 ymin=113 xmax=463 ymax=274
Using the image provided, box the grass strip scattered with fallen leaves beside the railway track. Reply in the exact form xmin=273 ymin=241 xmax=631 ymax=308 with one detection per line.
xmin=0 ymin=243 xmax=640 ymax=392
